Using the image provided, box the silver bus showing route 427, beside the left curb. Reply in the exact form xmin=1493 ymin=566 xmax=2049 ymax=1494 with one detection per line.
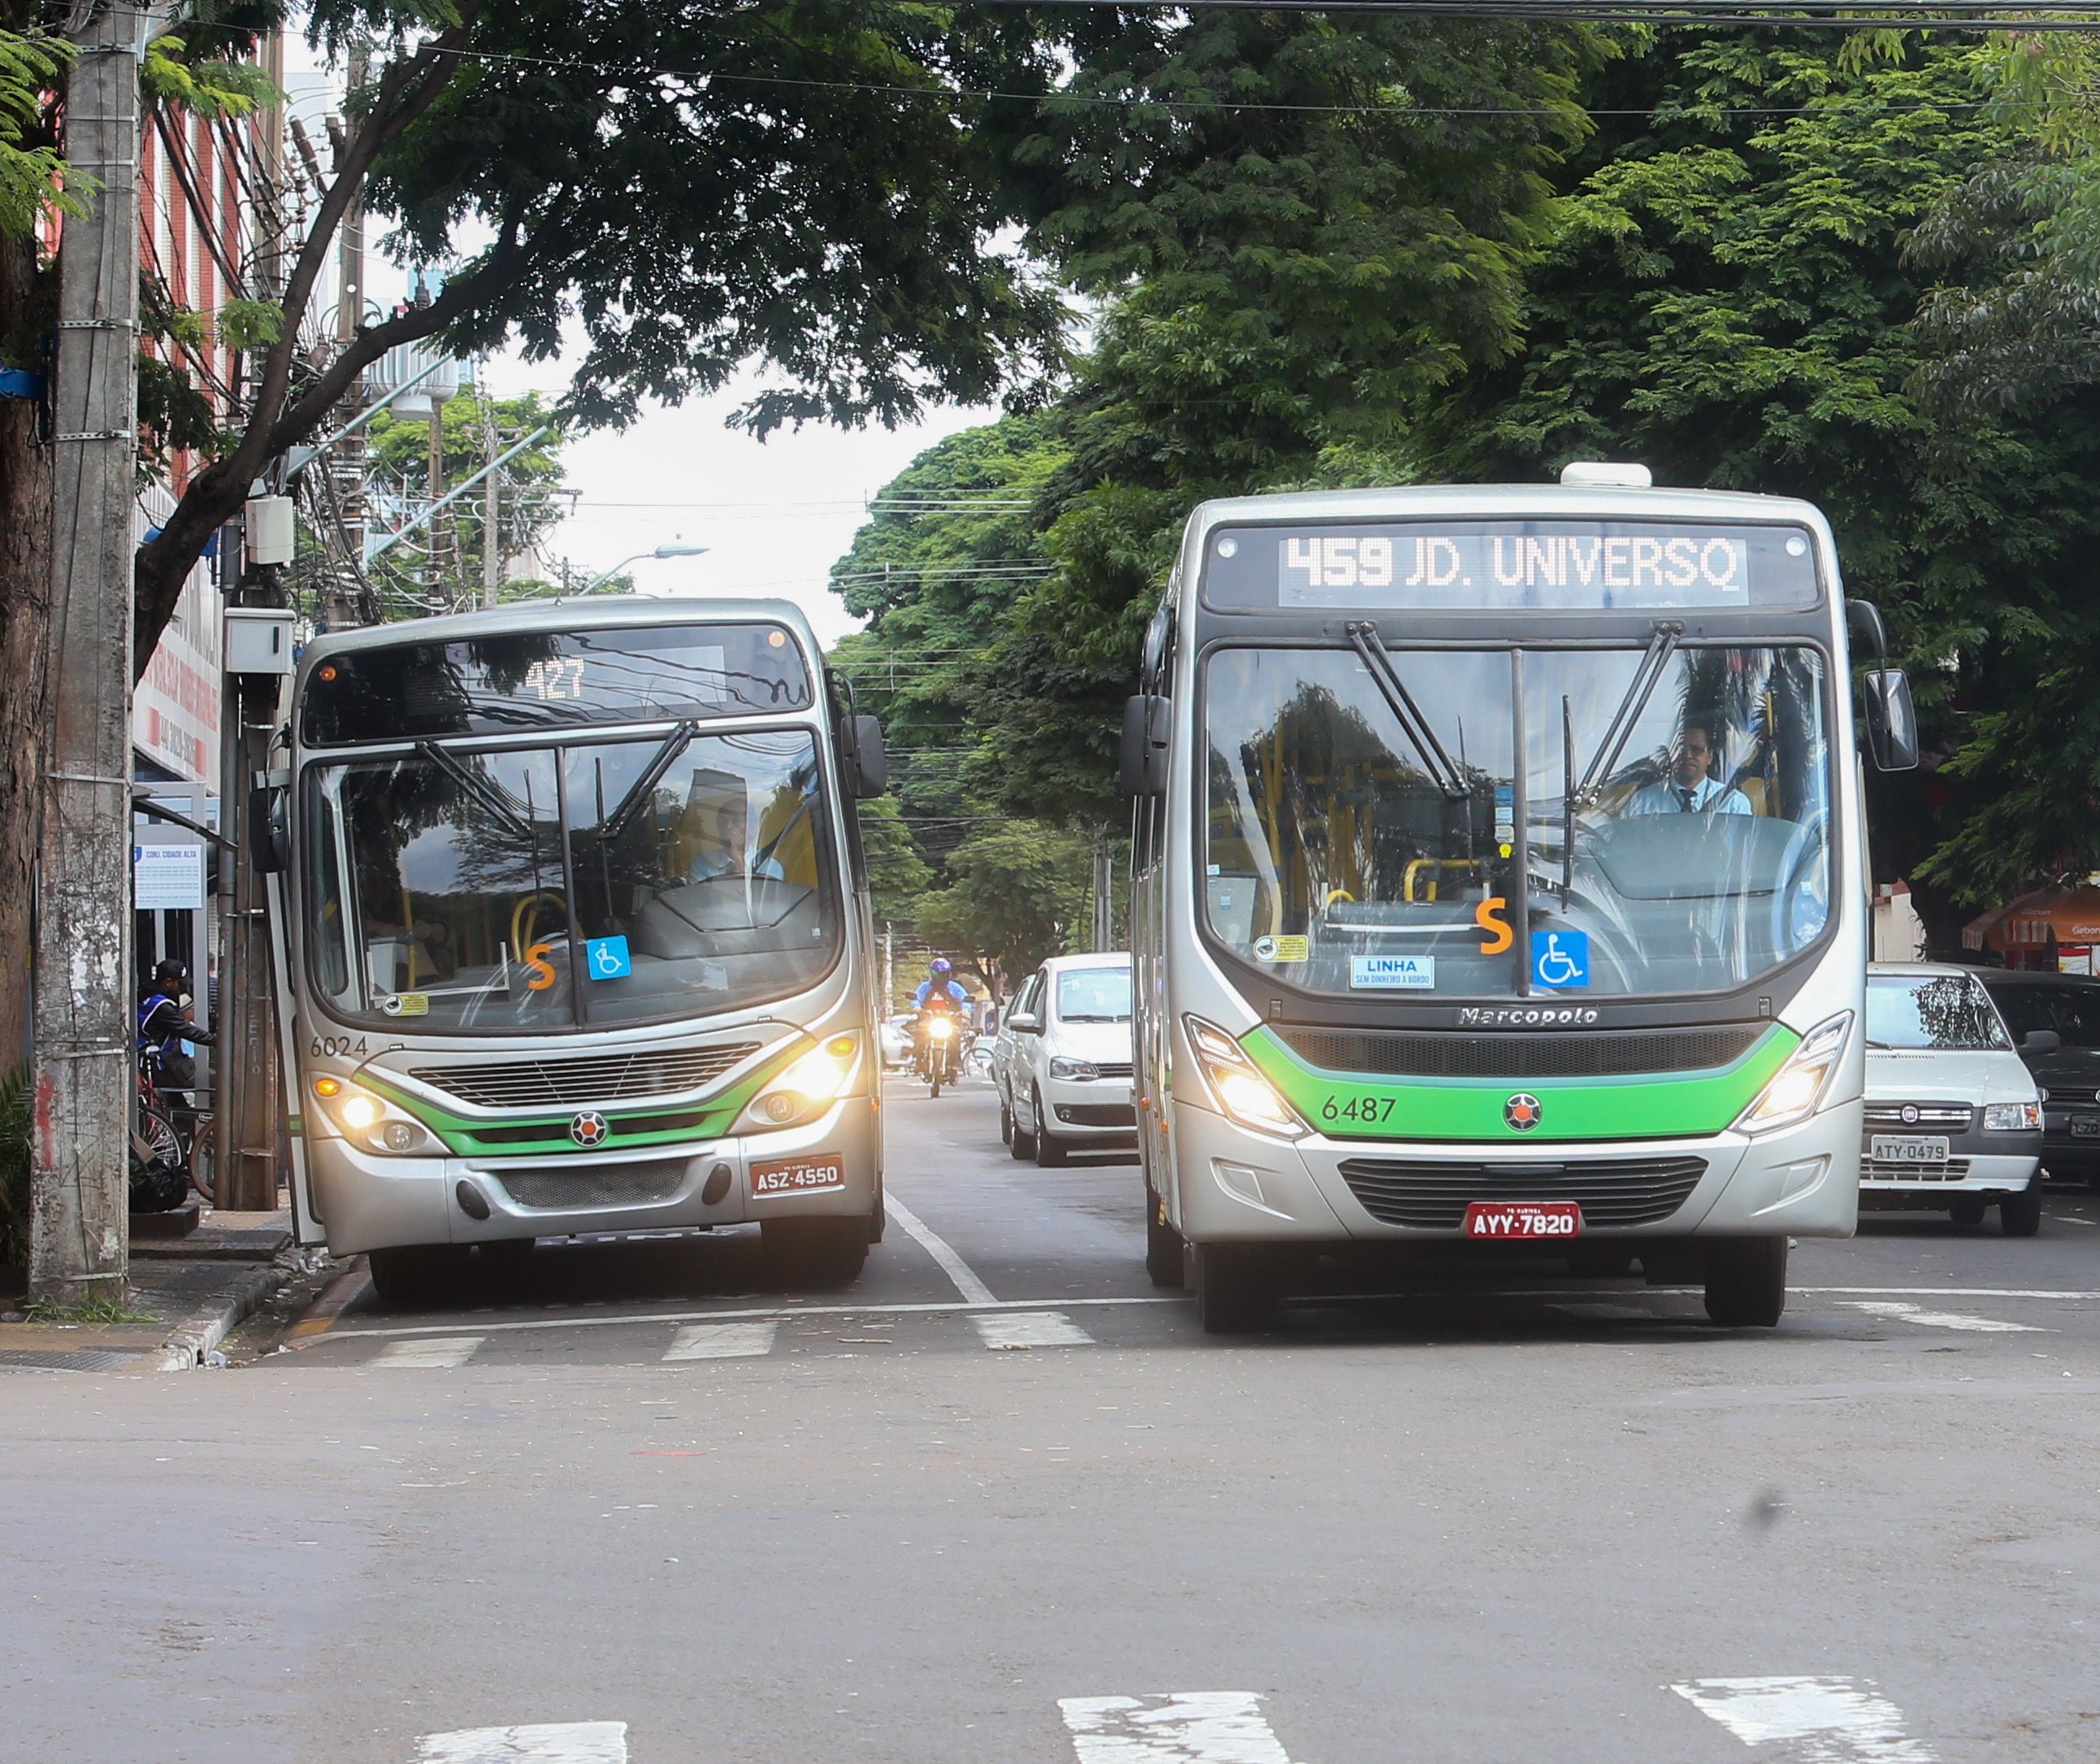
xmin=256 ymin=598 xmax=884 ymax=1302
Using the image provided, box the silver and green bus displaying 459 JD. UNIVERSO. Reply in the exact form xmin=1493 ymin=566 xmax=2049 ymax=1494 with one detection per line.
xmin=1123 ymin=467 xmax=1916 ymax=1332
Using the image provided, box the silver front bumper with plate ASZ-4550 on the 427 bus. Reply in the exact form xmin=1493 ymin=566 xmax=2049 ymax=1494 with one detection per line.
xmin=306 ymin=1097 xmax=882 ymax=1256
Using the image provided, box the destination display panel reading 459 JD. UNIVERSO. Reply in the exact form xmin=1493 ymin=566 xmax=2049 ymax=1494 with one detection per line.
xmin=1204 ymin=521 xmax=1816 ymax=611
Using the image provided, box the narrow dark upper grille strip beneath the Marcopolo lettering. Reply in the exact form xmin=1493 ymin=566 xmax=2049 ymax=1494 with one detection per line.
xmin=1270 ymin=1023 xmax=1770 ymax=1077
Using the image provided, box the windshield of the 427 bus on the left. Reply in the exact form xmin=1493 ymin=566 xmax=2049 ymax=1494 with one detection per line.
xmin=302 ymin=724 xmax=842 ymax=1033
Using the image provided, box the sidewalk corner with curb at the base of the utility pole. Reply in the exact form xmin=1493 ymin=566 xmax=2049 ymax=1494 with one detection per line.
xmin=0 ymin=1207 xmax=298 ymax=1374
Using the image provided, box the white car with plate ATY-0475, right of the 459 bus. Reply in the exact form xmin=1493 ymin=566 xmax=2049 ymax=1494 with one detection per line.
xmin=1859 ymin=962 xmax=2041 ymax=1237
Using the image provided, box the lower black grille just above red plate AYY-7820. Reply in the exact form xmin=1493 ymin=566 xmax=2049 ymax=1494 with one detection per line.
xmin=1342 ymin=1157 xmax=1705 ymax=1231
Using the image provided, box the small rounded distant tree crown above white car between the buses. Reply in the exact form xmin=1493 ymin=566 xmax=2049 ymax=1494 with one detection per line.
xmin=918 ymin=821 xmax=1094 ymax=979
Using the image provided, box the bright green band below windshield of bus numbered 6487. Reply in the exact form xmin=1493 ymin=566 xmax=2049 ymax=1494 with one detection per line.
xmin=1241 ymin=1023 xmax=1799 ymax=1145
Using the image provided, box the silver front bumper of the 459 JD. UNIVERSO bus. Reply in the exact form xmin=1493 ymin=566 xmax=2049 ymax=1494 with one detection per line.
xmin=1172 ymin=1101 xmax=1860 ymax=1243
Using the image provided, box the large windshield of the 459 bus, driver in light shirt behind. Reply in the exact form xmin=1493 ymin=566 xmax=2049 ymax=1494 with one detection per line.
xmin=1204 ymin=645 xmax=1831 ymax=997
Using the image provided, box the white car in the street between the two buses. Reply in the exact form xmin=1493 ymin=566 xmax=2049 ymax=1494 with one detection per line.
xmin=1002 ymin=954 xmax=1139 ymax=1166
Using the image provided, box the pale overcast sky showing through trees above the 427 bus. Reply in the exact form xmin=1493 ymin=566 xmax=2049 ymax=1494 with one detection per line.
xmin=285 ymin=33 xmax=997 ymax=647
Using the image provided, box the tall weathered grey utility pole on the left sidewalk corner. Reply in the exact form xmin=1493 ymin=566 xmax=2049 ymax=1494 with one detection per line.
xmin=29 ymin=0 xmax=143 ymax=1304
